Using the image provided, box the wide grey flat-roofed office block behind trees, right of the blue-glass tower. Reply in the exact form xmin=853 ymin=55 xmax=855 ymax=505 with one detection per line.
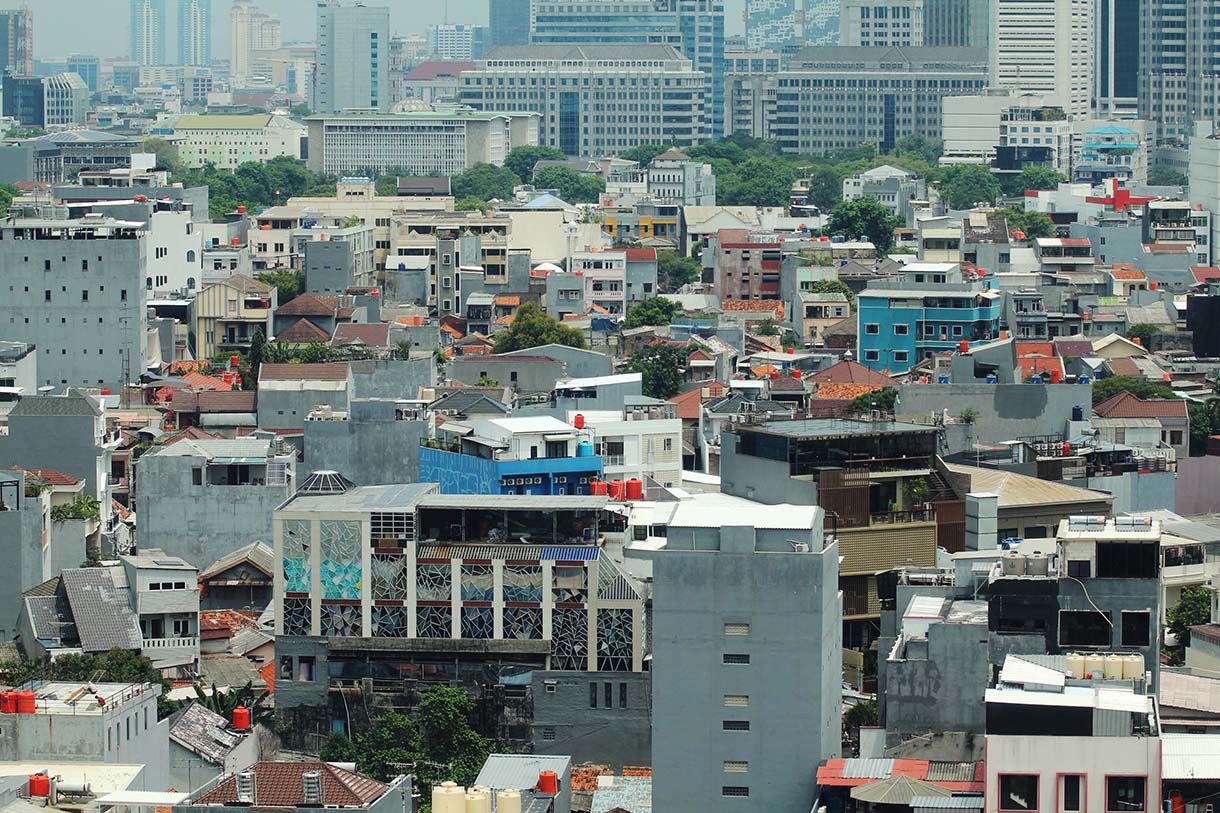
xmin=727 ymin=46 xmax=988 ymax=155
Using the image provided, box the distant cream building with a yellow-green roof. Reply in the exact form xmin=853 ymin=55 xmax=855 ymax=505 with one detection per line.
xmin=173 ymin=114 xmax=305 ymax=171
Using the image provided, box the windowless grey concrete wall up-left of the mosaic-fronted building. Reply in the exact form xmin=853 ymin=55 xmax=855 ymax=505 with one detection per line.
xmin=135 ymin=453 xmax=295 ymax=568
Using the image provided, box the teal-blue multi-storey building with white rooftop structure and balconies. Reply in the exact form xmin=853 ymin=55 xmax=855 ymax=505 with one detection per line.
xmin=856 ymin=262 xmax=1003 ymax=372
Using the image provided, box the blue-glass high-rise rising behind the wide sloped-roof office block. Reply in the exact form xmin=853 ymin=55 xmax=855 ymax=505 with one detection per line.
xmin=529 ymin=0 xmax=722 ymax=138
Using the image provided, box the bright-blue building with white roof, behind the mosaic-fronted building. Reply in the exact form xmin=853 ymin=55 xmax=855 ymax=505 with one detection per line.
xmin=420 ymin=416 xmax=603 ymax=494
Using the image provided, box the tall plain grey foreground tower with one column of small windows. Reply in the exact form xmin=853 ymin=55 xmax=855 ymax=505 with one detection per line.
xmin=628 ymin=504 xmax=843 ymax=813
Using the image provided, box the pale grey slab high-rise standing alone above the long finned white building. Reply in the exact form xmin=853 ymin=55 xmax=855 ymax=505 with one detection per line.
xmin=312 ymin=0 xmax=390 ymax=114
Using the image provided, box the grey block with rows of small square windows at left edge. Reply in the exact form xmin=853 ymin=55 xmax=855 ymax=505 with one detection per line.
xmin=0 ymin=215 xmax=151 ymax=392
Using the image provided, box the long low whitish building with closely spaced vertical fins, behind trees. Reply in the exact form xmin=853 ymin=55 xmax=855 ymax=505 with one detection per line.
xmin=307 ymin=105 xmax=540 ymax=176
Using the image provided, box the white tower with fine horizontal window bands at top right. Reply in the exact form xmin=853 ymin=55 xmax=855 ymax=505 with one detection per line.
xmin=991 ymin=0 xmax=1094 ymax=118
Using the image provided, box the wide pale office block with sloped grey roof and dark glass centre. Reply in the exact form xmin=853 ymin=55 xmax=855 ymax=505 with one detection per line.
xmin=461 ymin=44 xmax=708 ymax=156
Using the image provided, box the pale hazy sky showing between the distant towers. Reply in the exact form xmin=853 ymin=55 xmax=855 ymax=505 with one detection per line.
xmin=9 ymin=0 xmax=745 ymax=57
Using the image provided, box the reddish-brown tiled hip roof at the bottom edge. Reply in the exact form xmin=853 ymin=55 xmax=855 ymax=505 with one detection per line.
xmin=192 ymin=762 xmax=388 ymax=808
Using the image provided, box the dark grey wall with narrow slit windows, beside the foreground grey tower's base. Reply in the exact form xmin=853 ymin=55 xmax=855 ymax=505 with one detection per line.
xmin=529 ymin=671 xmax=653 ymax=770
